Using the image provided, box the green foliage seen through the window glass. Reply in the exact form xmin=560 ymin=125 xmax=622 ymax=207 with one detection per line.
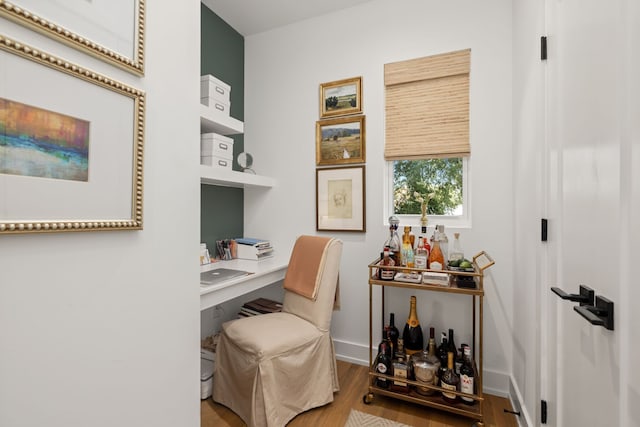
xmin=393 ymin=157 xmax=463 ymax=215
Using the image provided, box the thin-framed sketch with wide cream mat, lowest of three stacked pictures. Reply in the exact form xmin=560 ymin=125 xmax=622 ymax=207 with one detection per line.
xmin=316 ymin=166 xmax=366 ymax=232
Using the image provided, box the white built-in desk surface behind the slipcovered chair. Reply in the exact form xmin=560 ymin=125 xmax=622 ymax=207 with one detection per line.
xmin=200 ymin=254 xmax=289 ymax=311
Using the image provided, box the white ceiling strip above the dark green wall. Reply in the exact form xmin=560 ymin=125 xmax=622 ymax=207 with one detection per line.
xmin=201 ymin=0 xmax=371 ymax=37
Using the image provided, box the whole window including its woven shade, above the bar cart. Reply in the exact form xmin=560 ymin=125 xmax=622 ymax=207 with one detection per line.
xmin=384 ymin=49 xmax=471 ymax=225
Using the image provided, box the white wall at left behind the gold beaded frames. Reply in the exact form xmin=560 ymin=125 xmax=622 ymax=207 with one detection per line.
xmin=0 ymin=1 xmax=200 ymax=427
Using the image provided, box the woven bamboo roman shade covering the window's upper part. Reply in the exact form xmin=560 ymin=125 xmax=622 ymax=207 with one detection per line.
xmin=384 ymin=49 xmax=471 ymax=160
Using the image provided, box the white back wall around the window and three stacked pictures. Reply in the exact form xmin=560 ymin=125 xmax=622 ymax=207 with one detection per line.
xmin=245 ymin=0 xmax=514 ymax=392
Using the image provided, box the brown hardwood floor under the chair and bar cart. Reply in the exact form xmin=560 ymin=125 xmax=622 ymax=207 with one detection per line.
xmin=200 ymin=361 xmax=518 ymax=427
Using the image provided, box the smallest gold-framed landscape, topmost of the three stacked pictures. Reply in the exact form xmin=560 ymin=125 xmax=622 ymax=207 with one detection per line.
xmin=320 ymin=77 xmax=362 ymax=119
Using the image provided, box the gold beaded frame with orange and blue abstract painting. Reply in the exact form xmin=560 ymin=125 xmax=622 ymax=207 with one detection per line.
xmin=0 ymin=34 xmax=145 ymax=236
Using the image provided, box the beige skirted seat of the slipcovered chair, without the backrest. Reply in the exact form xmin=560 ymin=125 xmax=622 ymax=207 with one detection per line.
xmin=213 ymin=313 xmax=339 ymax=427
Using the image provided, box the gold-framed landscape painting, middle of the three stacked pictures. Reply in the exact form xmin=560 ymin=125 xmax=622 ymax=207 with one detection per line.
xmin=316 ymin=116 xmax=366 ymax=166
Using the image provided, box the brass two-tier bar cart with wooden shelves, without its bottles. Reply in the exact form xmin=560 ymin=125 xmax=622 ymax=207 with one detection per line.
xmin=362 ymin=252 xmax=494 ymax=427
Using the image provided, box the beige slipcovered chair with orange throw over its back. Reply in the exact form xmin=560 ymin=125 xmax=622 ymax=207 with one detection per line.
xmin=213 ymin=236 xmax=342 ymax=427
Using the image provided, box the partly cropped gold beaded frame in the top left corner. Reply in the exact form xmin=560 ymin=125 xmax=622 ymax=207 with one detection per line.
xmin=0 ymin=0 xmax=145 ymax=76
